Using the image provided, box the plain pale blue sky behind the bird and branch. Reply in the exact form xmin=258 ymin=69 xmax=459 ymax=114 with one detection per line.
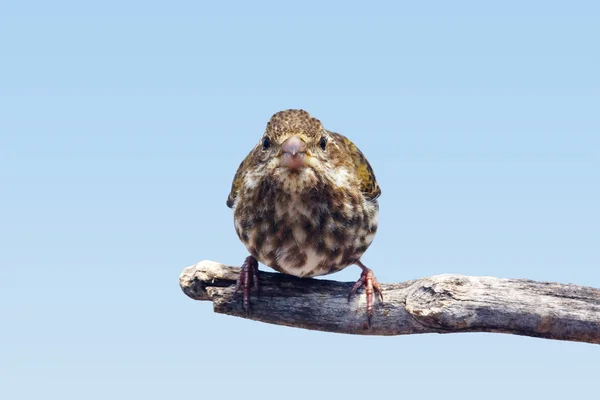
xmin=0 ymin=1 xmax=600 ymax=399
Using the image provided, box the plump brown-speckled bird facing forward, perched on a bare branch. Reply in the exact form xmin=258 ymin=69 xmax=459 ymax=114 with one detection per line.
xmin=226 ymin=109 xmax=383 ymax=326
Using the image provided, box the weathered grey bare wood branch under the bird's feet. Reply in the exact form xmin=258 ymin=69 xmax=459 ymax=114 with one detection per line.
xmin=179 ymin=261 xmax=600 ymax=343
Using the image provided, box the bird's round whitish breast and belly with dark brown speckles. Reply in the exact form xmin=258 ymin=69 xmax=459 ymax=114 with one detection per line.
xmin=234 ymin=178 xmax=378 ymax=277
